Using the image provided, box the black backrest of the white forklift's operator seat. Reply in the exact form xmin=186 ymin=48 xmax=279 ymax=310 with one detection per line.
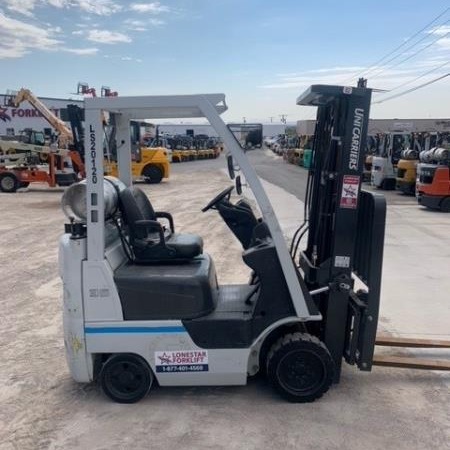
xmin=119 ymin=186 xmax=156 ymax=239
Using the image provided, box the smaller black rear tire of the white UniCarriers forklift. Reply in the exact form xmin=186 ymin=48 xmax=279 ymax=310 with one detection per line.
xmin=100 ymin=353 xmax=154 ymax=403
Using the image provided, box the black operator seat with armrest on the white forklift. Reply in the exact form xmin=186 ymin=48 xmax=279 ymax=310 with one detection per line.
xmin=119 ymin=186 xmax=203 ymax=264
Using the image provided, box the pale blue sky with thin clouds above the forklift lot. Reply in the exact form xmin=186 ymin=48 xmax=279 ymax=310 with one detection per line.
xmin=0 ymin=0 xmax=450 ymax=123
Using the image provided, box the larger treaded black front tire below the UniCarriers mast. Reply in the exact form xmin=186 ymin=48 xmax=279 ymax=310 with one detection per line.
xmin=266 ymin=333 xmax=334 ymax=403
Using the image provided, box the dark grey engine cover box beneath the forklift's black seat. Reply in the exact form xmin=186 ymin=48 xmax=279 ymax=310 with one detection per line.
xmin=114 ymin=254 xmax=218 ymax=320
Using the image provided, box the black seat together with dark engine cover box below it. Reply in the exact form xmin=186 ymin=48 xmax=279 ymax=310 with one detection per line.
xmin=114 ymin=186 xmax=218 ymax=320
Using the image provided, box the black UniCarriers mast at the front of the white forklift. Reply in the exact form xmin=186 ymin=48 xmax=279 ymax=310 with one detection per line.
xmin=297 ymin=83 xmax=386 ymax=381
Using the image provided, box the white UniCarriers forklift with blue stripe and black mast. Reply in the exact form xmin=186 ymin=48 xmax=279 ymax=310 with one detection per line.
xmin=59 ymin=85 xmax=440 ymax=403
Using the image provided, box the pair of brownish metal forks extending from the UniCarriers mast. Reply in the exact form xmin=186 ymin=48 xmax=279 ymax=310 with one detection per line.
xmin=372 ymin=336 xmax=450 ymax=371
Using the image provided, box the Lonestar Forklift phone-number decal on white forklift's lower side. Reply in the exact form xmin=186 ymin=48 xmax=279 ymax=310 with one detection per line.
xmin=155 ymin=350 xmax=209 ymax=372
